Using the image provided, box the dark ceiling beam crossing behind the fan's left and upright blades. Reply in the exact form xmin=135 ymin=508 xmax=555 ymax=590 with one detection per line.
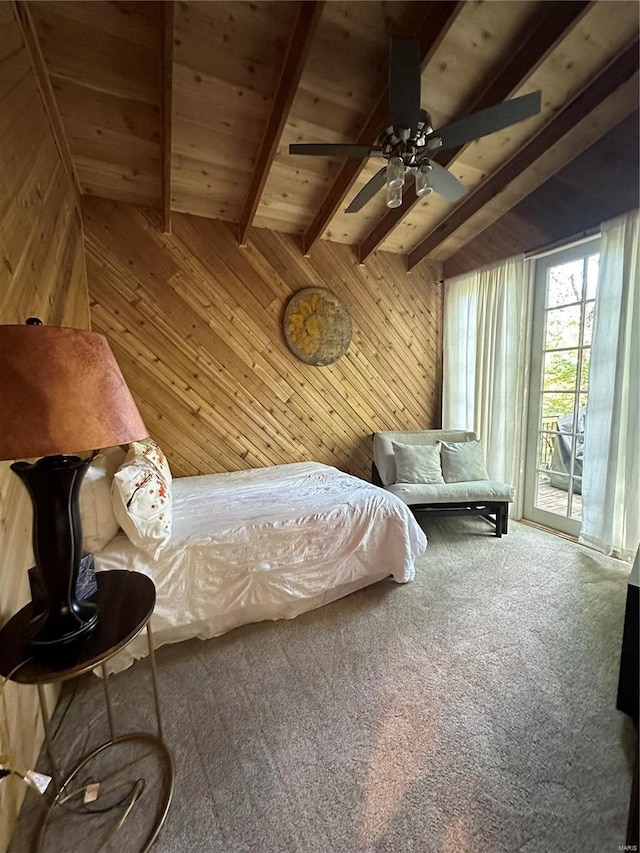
xmin=302 ymin=0 xmax=464 ymax=256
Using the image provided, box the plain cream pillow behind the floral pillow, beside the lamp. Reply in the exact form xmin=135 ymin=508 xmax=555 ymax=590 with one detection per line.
xmin=79 ymin=447 xmax=126 ymax=553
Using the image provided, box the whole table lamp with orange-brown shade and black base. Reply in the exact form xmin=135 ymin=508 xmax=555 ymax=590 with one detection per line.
xmin=0 ymin=318 xmax=149 ymax=652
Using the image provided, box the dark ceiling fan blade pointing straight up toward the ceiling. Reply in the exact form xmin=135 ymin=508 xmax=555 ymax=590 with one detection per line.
xmin=389 ymin=38 xmax=421 ymax=139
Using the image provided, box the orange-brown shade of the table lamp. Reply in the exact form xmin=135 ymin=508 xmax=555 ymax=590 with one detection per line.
xmin=0 ymin=325 xmax=149 ymax=459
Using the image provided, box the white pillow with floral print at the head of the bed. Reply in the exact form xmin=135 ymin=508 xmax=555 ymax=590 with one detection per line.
xmin=111 ymin=442 xmax=173 ymax=559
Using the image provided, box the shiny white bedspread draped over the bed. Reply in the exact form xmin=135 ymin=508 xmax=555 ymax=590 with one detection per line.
xmin=95 ymin=462 xmax=427 ymax=671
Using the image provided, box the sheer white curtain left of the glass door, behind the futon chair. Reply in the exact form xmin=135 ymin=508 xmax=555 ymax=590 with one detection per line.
xmin=442 ymin=255 xmax=532 ymax=518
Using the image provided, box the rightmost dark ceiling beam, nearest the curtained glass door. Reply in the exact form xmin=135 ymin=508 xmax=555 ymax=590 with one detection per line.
xmin=407 ymin=40 xmax=640 ymax=270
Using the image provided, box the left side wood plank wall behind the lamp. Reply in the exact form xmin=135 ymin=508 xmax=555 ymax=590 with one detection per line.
xmin=0 ymin=3 xmax=89 ymax=851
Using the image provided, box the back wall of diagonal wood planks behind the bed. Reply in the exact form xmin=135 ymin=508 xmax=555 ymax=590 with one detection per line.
xmin=83 ymin=198 xmax=442 ymax=478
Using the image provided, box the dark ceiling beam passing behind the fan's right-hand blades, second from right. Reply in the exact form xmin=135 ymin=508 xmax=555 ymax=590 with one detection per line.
xmin=358 ymin=0 xmax=592 ymax=264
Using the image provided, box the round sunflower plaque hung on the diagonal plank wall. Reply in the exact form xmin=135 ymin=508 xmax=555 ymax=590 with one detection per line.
xmin=284 ymin=287 xmax=351 ymax=366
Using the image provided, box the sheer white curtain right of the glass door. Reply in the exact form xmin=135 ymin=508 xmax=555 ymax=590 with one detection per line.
xmin=580 ymin=211 xmax=640 ymax=559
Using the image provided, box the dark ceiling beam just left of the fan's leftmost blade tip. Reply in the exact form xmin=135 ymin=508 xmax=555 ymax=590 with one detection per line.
xmin=238 ymin=0 xmax=323 ymax=246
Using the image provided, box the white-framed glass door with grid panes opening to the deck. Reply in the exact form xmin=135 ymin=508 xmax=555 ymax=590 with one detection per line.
xmin=524 ymin=238 xmax=600 ymax=537
